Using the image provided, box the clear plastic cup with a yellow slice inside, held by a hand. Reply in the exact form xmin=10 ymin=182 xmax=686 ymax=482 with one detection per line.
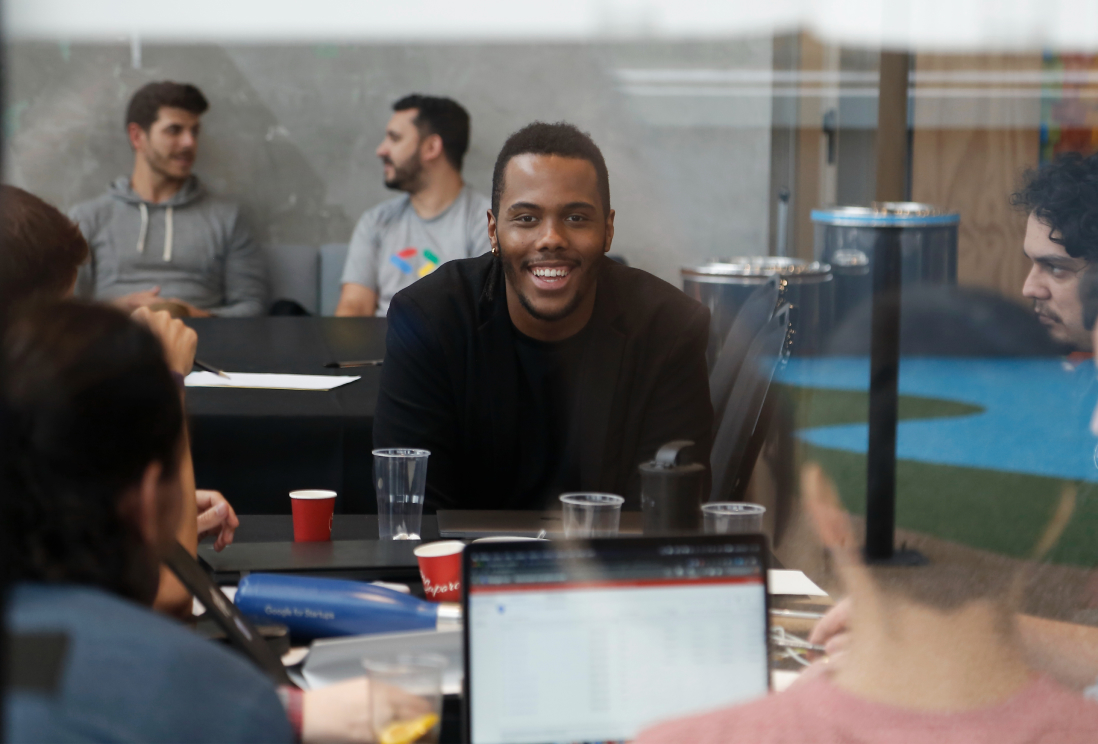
xmin=362 ymin=654 xmax=446 ymax=744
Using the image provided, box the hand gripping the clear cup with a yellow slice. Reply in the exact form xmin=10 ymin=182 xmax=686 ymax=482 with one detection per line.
xmin=301 ymin=677 xmax=434 ymax=743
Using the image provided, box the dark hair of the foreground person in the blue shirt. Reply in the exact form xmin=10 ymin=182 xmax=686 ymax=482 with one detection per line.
xmin=0 ymin=302 xmax=183 ymax=602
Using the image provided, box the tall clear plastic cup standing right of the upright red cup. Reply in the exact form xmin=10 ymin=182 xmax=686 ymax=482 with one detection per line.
xmin=373 ymin=449 xmax=430 ymax=540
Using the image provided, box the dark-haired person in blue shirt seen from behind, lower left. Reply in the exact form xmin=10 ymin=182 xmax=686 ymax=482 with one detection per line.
xmin=0 ymin=302 xmax=418 ymax=742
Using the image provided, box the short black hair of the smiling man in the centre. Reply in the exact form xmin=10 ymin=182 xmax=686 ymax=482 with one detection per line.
xmin=492 ymin=122 xmax=610 ymax=217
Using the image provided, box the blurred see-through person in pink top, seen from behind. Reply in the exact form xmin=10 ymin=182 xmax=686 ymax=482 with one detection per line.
xmin=636 ymin=288 xmax=1098 ymax=744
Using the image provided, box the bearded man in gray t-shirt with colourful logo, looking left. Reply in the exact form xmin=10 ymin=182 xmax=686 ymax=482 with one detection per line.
xmin=336 ymin=94 xmax=492 ymax=316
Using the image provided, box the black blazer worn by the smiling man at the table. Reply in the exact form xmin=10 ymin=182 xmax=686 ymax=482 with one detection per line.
xmin=373 ymin=253 xmax=713 ymax=510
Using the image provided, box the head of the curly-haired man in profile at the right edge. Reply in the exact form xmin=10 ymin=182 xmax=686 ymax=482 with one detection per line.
xmin=1011 ymin=153 xmax=1098 ymax=351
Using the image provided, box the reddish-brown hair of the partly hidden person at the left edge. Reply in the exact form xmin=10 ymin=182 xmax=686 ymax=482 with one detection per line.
xmin=0 ymin=185 xmax=88 ymax=315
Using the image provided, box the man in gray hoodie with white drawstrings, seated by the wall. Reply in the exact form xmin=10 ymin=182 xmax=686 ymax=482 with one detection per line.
xmin=70 ymin=81 xmax=267 ymax=317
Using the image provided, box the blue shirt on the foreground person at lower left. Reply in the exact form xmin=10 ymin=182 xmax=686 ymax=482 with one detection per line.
xmin=9 ymin=584 xmax=289 ymax=741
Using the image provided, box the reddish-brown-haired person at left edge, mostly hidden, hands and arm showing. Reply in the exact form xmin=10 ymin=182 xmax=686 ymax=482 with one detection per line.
xmin=0 ymin=185 xmax=239 ymax=617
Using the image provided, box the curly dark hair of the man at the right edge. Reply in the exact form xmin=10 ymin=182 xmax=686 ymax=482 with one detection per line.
xmin=1010 ymin=153 xmax=1098 ymax=261
